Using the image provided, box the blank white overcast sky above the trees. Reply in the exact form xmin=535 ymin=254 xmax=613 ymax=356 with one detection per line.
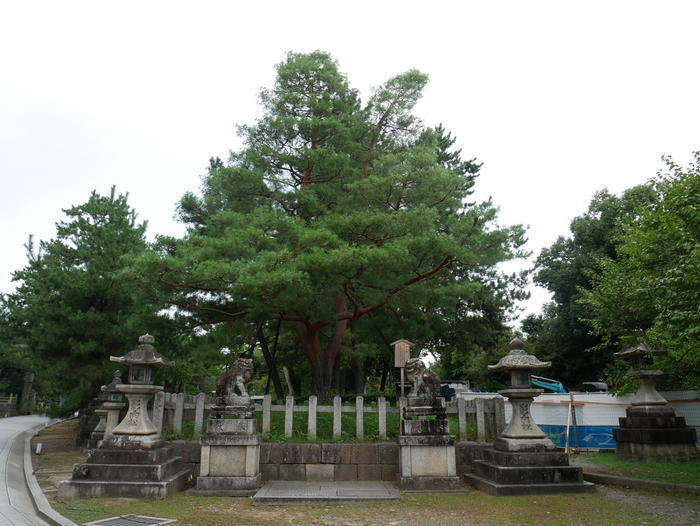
xmin=0 ymin=0 xmax=700 ymax=326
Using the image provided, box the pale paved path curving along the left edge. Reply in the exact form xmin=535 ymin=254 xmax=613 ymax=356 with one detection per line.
xmin=0 ymin=415 xmax=49 ymax=526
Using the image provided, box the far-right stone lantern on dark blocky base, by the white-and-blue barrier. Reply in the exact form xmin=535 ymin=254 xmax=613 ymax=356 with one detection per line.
xmin=613 ymin=343 xmax=698 ymax=462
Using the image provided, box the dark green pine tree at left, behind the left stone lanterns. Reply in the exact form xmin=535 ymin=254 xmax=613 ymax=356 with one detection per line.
xmin=2 ymin=188 xmax=180 ymax=411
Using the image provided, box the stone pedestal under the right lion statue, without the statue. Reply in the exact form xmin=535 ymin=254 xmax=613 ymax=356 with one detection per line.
xmin=398 ymin=396 xmax=461 ymax=491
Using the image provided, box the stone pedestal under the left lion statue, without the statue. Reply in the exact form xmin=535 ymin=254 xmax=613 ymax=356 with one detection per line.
xmin=187 ymin=396 xmax=261 ymax=497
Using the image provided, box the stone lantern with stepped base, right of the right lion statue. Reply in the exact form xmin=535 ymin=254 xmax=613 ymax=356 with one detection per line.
xmin=464 ymin=338 xmax=594 ymax=495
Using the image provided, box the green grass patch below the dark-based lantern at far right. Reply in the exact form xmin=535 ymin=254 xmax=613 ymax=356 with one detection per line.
xmin=585 ymin=453 xmax=700 ymax=486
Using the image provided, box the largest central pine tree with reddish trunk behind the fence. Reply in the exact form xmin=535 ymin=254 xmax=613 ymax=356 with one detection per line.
xmin=149 ymin=52 xmax=523 ymax=396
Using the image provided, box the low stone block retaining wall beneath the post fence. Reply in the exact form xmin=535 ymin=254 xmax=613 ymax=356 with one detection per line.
xmin=170 ymin=440 xmax=492 ymax=481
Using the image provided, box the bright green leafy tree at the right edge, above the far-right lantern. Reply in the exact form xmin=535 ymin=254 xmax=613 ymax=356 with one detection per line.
xmin=580 ymin=152 xmax=700 ymax=389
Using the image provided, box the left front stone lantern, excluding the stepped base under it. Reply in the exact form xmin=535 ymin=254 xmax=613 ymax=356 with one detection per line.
xmin=105 ymin=334 xmax=173 ymax=449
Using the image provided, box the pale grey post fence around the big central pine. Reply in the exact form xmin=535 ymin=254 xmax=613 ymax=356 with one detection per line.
xmin=152 ymin=393 xmax=505 ymax=442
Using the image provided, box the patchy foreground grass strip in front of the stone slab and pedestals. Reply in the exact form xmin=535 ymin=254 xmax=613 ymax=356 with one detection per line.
xmin=52 ymin=491 xmax=660 ymax=526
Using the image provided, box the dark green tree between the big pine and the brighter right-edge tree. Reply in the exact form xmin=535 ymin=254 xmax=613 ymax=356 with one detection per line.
xmin=522 ymin=185 xmax=655 ymax=386
